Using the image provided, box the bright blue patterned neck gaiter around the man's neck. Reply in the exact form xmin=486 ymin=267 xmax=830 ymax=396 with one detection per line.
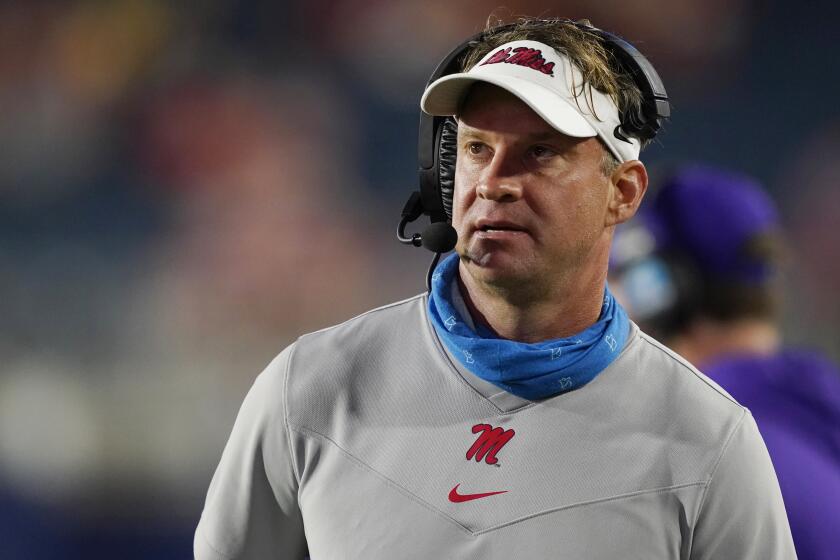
xmin=428 ymin=253 xmax=630 ymax=400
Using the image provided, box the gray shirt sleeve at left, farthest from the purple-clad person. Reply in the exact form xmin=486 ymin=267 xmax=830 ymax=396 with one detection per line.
xmin=193 ymin=346 xmax=306 ymax=560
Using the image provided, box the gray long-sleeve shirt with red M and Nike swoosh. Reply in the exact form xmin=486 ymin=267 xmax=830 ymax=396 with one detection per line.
xmin=195 ymin=296 xmax=796 ymax=560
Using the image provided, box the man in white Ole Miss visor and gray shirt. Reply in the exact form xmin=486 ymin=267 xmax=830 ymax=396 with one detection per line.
xmin=195 ymin=20 xmax=795 ymax=560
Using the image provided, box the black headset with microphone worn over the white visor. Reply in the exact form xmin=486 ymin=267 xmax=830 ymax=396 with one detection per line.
xmin=397 ymin=18 xmax=671 ymax=285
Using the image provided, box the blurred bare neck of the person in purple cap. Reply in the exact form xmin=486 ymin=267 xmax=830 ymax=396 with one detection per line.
xmin=669 ymin=319 xmax=781 ymax=366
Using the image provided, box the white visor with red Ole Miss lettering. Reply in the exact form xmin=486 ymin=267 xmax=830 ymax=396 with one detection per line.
xmin=420 ymin=41 xmax=640 ymax=162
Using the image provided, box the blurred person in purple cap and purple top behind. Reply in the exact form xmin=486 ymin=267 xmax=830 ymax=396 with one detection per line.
xmin=611 ymin=165 xmax=840 ymax=560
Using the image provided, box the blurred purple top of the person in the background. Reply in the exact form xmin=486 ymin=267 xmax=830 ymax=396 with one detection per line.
xmin=702 ymin=350 xmax=840 ymax=560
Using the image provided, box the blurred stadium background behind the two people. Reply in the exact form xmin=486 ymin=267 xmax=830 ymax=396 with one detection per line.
xmin=0 ymin=0 xmax=840 ymax=559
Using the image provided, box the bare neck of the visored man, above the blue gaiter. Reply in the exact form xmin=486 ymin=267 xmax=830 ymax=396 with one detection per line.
xmin=456 ymin=263 xmax=606 ymax=343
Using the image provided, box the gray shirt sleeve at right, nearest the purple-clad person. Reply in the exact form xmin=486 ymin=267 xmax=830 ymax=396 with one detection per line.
xmin=691 ymin=410 xmax=796 ymax=560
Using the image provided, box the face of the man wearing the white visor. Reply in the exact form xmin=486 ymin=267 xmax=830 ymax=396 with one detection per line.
xmin=452 ymin=84 xmax=610 ymax=290
